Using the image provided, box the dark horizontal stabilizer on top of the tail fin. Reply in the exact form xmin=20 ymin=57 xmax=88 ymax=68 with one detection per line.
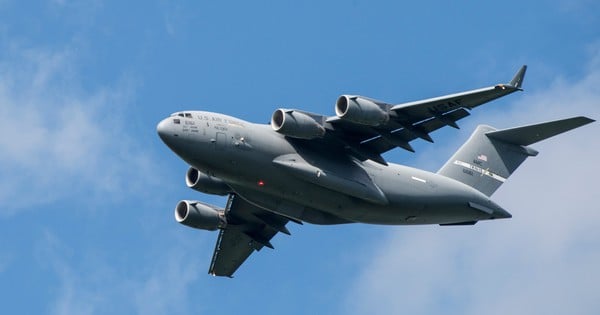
xmin=486 ymin=116 xmax=594 ymax=146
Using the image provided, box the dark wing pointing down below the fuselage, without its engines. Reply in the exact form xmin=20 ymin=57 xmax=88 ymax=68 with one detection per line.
xmin=208 ymin=194 xmax=290 ymax=277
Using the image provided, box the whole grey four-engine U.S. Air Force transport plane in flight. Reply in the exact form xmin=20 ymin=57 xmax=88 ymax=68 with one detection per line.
xmin=157 ymin=66 xmax=594 ymax=277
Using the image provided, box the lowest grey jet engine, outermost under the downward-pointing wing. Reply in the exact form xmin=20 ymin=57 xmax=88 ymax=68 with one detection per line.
xmin=175 ymin=200 xmax=227 ymax=231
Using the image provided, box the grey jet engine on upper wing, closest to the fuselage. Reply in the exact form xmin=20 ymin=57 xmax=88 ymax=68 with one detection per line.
xmin=271 ymin=109 xmax=325 ymax=140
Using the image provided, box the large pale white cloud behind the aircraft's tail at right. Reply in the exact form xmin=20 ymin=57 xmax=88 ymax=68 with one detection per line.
xmin=345 ymin=49 xmax=600 ymax=314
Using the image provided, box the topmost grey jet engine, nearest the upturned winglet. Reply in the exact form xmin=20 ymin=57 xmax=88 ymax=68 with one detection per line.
xmin=335 ymin=95 xmax=390 ymax=126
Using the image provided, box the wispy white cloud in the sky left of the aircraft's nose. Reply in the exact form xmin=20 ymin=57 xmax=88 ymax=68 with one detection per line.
xmin=0 ymin=45 xmax=159 ymax=216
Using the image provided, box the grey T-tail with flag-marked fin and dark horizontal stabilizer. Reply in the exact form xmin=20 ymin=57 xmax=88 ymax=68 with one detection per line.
xmin=438 ymin=117 xmax=594 ymax=196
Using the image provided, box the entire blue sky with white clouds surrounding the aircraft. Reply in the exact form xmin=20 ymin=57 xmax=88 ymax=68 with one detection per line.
xmin=0 ymin=0 xmax=600 ymax=314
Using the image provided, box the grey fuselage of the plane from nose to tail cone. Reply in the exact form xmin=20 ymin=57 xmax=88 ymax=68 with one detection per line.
xmin=157 ymin=111 xmax=510 ymax=225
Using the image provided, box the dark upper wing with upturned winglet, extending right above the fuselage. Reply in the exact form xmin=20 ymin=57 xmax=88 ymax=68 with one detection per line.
xmin=327 ymin=66 xmax=527 ymax=164
